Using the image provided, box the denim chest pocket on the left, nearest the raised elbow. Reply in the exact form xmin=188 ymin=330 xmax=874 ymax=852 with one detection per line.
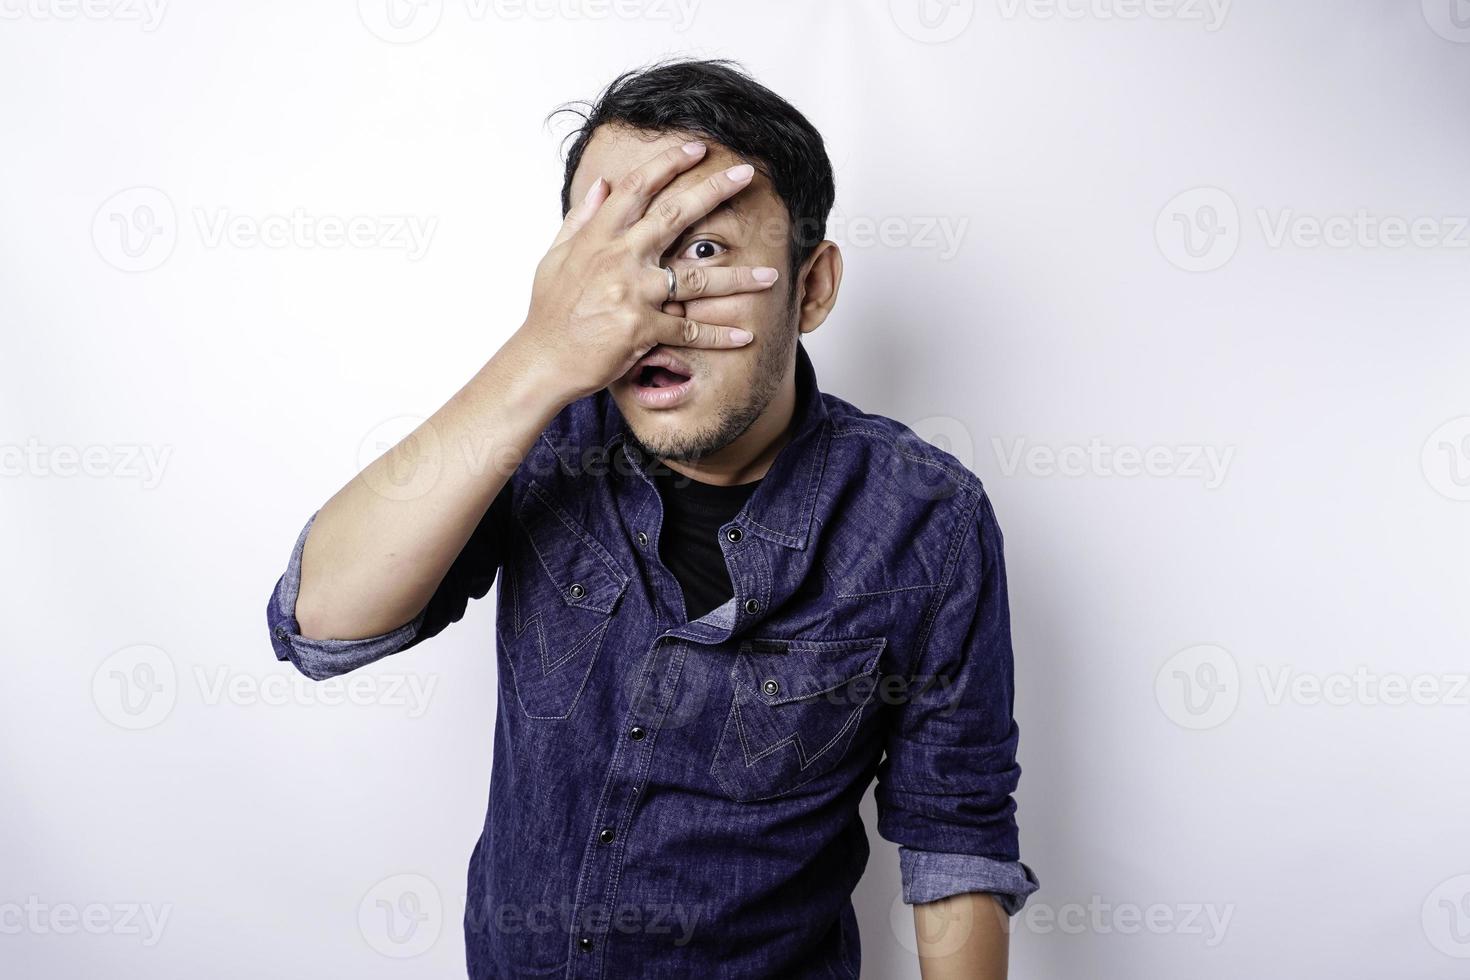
xmin=495 ymin=483 xmax=628 ymax=718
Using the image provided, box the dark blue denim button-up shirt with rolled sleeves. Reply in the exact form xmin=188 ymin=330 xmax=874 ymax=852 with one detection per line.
xmin=268 ymin=344 xmax=1038 ymax=980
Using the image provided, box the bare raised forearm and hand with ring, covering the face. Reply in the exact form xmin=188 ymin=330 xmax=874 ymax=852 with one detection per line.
xmin=285 ymin=144 xmax=770 ymax=641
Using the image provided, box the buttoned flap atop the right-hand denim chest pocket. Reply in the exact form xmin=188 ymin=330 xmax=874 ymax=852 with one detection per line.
xmin=739 ymin=636 xmax=888 ymax=705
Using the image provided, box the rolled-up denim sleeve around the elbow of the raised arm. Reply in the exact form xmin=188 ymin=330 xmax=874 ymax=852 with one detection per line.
xmin=266 ymin=482 xmax=512 ymax=680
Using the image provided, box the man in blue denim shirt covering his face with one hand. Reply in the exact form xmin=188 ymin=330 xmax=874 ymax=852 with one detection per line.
xmin=269 ymin=62 xmax=1036 ymax=980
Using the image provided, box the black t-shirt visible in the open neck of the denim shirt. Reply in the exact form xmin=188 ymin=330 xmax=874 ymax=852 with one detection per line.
xmin=650 ymin=463 xmax=760 ymax=620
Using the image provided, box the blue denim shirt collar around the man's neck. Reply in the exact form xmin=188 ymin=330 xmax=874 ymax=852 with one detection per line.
xmin=604 ymin=338 xmax=832 ymax=550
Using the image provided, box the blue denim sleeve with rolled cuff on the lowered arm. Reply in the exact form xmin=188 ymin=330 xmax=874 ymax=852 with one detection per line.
xmin=876 ymin=491 xmax=1039 ymax=914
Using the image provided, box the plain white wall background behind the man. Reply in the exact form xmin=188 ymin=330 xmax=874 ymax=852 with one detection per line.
xmin=0 ymin=0 xmax=1470 ymax=980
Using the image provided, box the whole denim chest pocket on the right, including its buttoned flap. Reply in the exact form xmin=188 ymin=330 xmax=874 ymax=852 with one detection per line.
xmin=710 ymin=636 xmax=886 ymax=802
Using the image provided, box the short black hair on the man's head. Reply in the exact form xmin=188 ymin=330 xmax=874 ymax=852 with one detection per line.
xmin=551 ymin=59 xmax=836 ymax=278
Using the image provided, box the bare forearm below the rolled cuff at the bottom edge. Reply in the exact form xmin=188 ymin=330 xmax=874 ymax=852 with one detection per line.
xmin=914 ymin=892 xmax=1010 ymax=980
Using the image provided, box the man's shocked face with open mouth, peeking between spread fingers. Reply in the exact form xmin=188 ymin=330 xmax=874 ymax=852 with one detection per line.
xmin=570 ymin=126 xmax=797 ymax=463
